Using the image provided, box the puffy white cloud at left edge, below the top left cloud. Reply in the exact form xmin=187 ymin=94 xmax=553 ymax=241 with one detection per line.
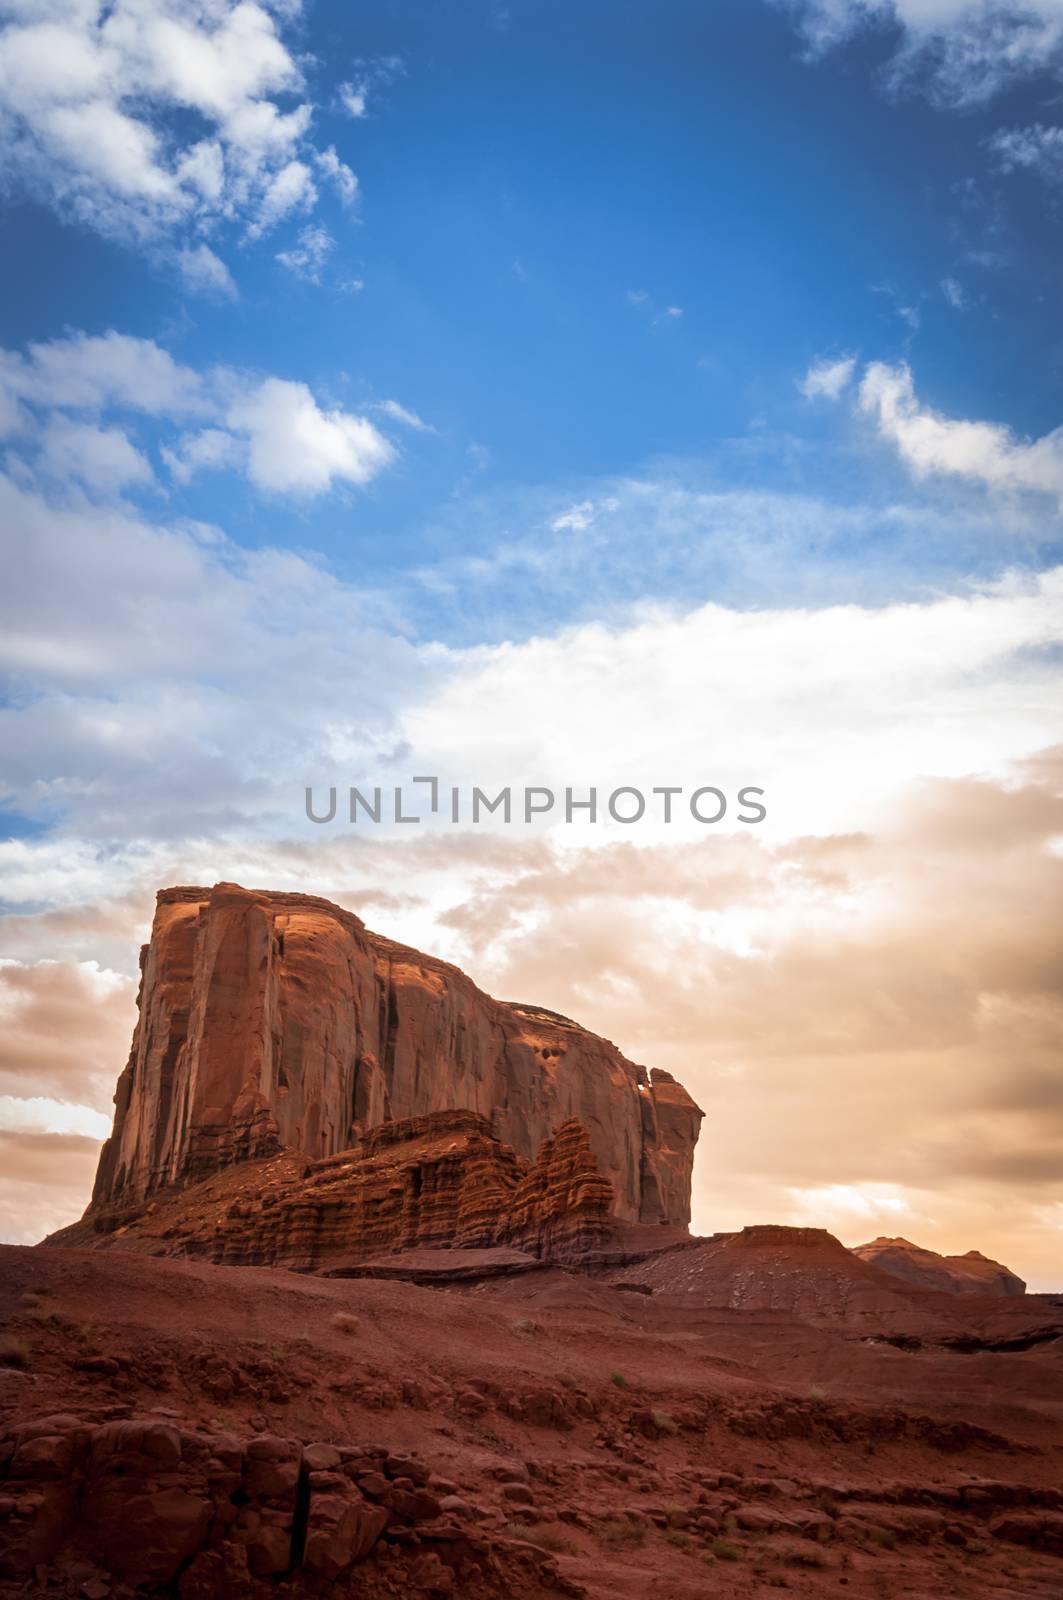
xmin=0 ymin=324 xmax=403 ymax=496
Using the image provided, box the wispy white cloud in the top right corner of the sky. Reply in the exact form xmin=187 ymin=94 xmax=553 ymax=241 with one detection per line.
xmin=781 ymin=0 xmax=1063 ymax=107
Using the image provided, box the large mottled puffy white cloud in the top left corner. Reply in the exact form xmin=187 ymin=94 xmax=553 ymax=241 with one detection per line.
xmin=0 ymin=0 xmax=361 ymax=246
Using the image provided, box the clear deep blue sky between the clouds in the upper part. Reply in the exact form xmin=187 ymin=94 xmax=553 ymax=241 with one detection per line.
xmin=0 ymin=3 xmax=1063 ymax=638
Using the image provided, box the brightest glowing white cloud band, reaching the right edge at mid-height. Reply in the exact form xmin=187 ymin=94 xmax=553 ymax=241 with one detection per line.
xmin=403 ymin=568 xmax=1063 ymax=838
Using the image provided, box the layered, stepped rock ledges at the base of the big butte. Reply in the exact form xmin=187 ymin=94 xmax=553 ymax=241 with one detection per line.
xmin=60 ymin=1110 xmax=613 ymax=1274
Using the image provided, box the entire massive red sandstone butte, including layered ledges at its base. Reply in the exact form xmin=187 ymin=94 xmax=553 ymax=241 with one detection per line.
xmin=68 ymin=883 xmax=703 ymax=1269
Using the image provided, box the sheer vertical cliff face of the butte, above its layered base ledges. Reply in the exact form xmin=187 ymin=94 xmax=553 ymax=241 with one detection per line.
xmin=90 ymin=883 xmax=703 ymax=1227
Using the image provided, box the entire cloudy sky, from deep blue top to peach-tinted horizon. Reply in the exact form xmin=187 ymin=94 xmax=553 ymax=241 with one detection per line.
xmin=0 ymin=0 xmax=1063 ymax=1288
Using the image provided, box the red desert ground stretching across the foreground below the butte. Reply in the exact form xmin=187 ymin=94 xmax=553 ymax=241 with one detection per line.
xmin=0 ymin=1235 xmax=1063 ymax=1600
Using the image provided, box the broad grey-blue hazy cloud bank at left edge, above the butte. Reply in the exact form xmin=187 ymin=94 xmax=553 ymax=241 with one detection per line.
xmin=0 ymin=462 xmax=429 ymax=832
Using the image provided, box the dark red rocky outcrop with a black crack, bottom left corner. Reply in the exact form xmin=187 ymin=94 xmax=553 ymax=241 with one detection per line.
xmin=0 ymin=1413 xmax=580 ymax=1600
